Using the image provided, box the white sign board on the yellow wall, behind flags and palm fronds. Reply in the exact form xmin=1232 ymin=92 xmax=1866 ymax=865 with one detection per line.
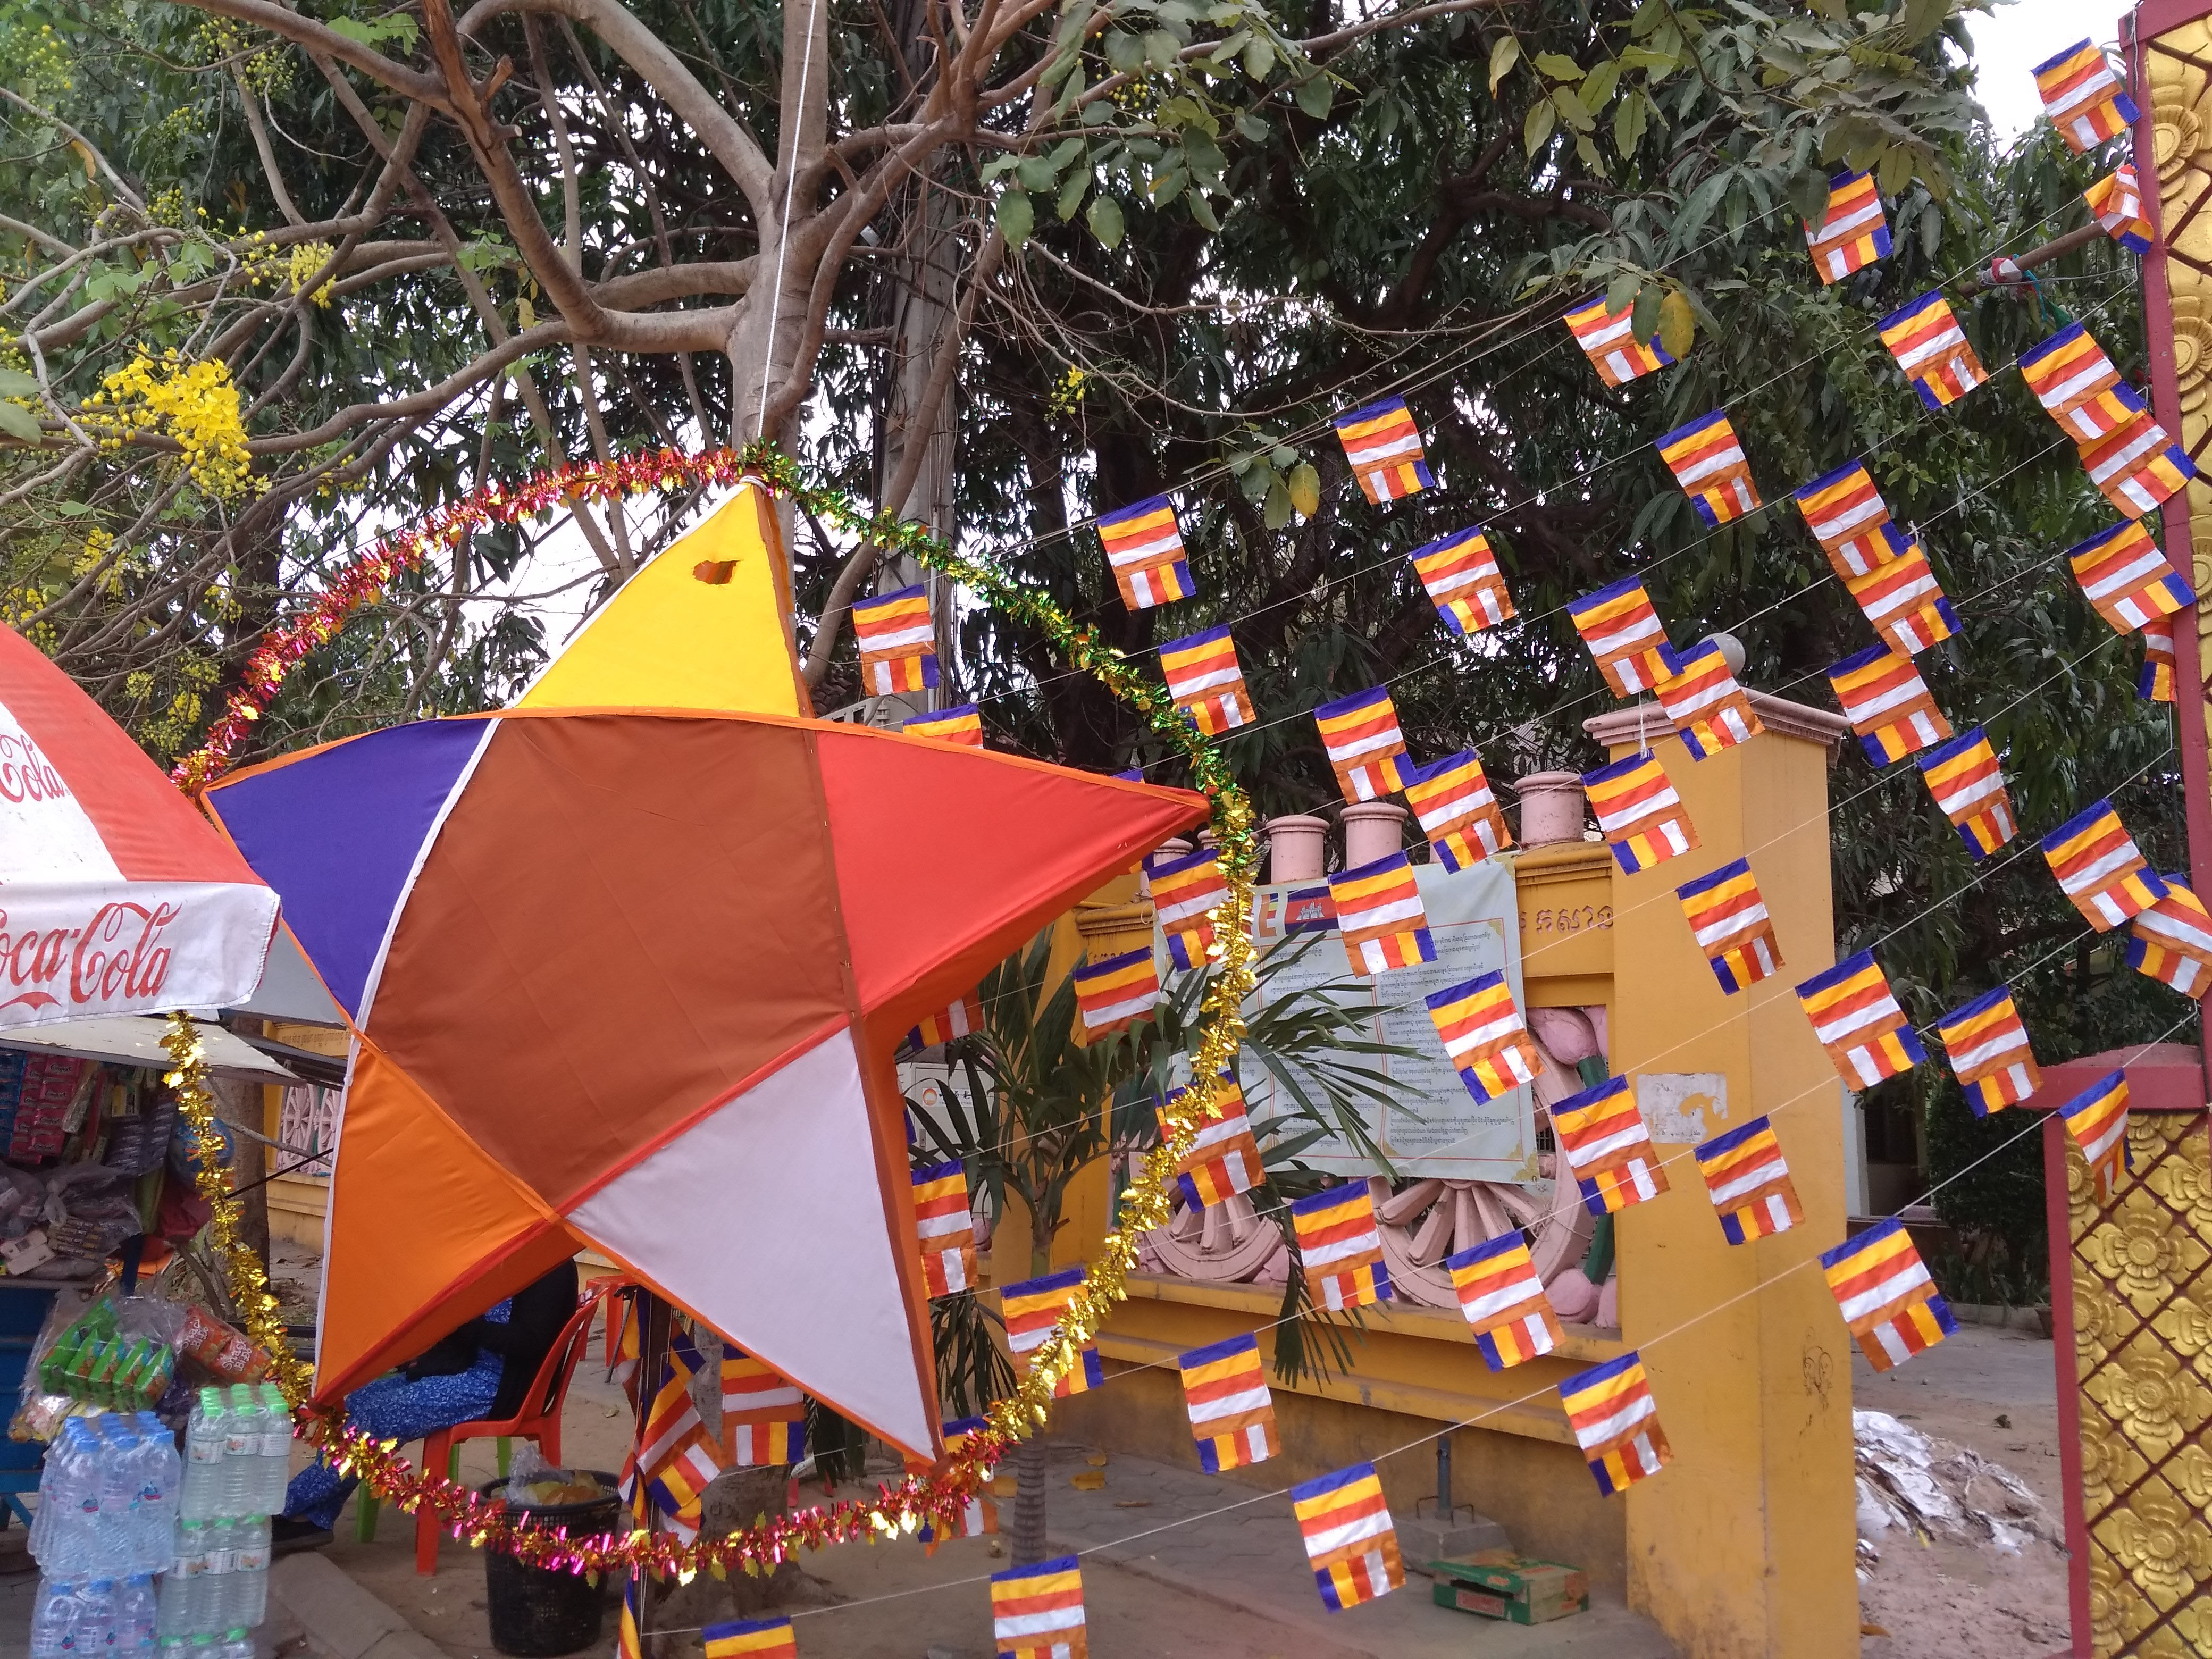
xmin=1239 ymin=858 xmax=1537 ymax=1181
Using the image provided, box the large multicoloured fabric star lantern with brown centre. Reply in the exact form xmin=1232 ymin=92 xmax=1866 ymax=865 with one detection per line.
xmin=208 ymin=496 xmax=1205 ymax=1451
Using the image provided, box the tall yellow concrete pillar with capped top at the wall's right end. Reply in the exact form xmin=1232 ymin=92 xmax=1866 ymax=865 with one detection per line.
xmin=1586 ymin=694 xmax=1858 ymax=1659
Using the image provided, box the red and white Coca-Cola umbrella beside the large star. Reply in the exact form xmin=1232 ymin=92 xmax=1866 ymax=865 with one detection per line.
xmin=0 ymin=628 xmax=276 ymax=1028
